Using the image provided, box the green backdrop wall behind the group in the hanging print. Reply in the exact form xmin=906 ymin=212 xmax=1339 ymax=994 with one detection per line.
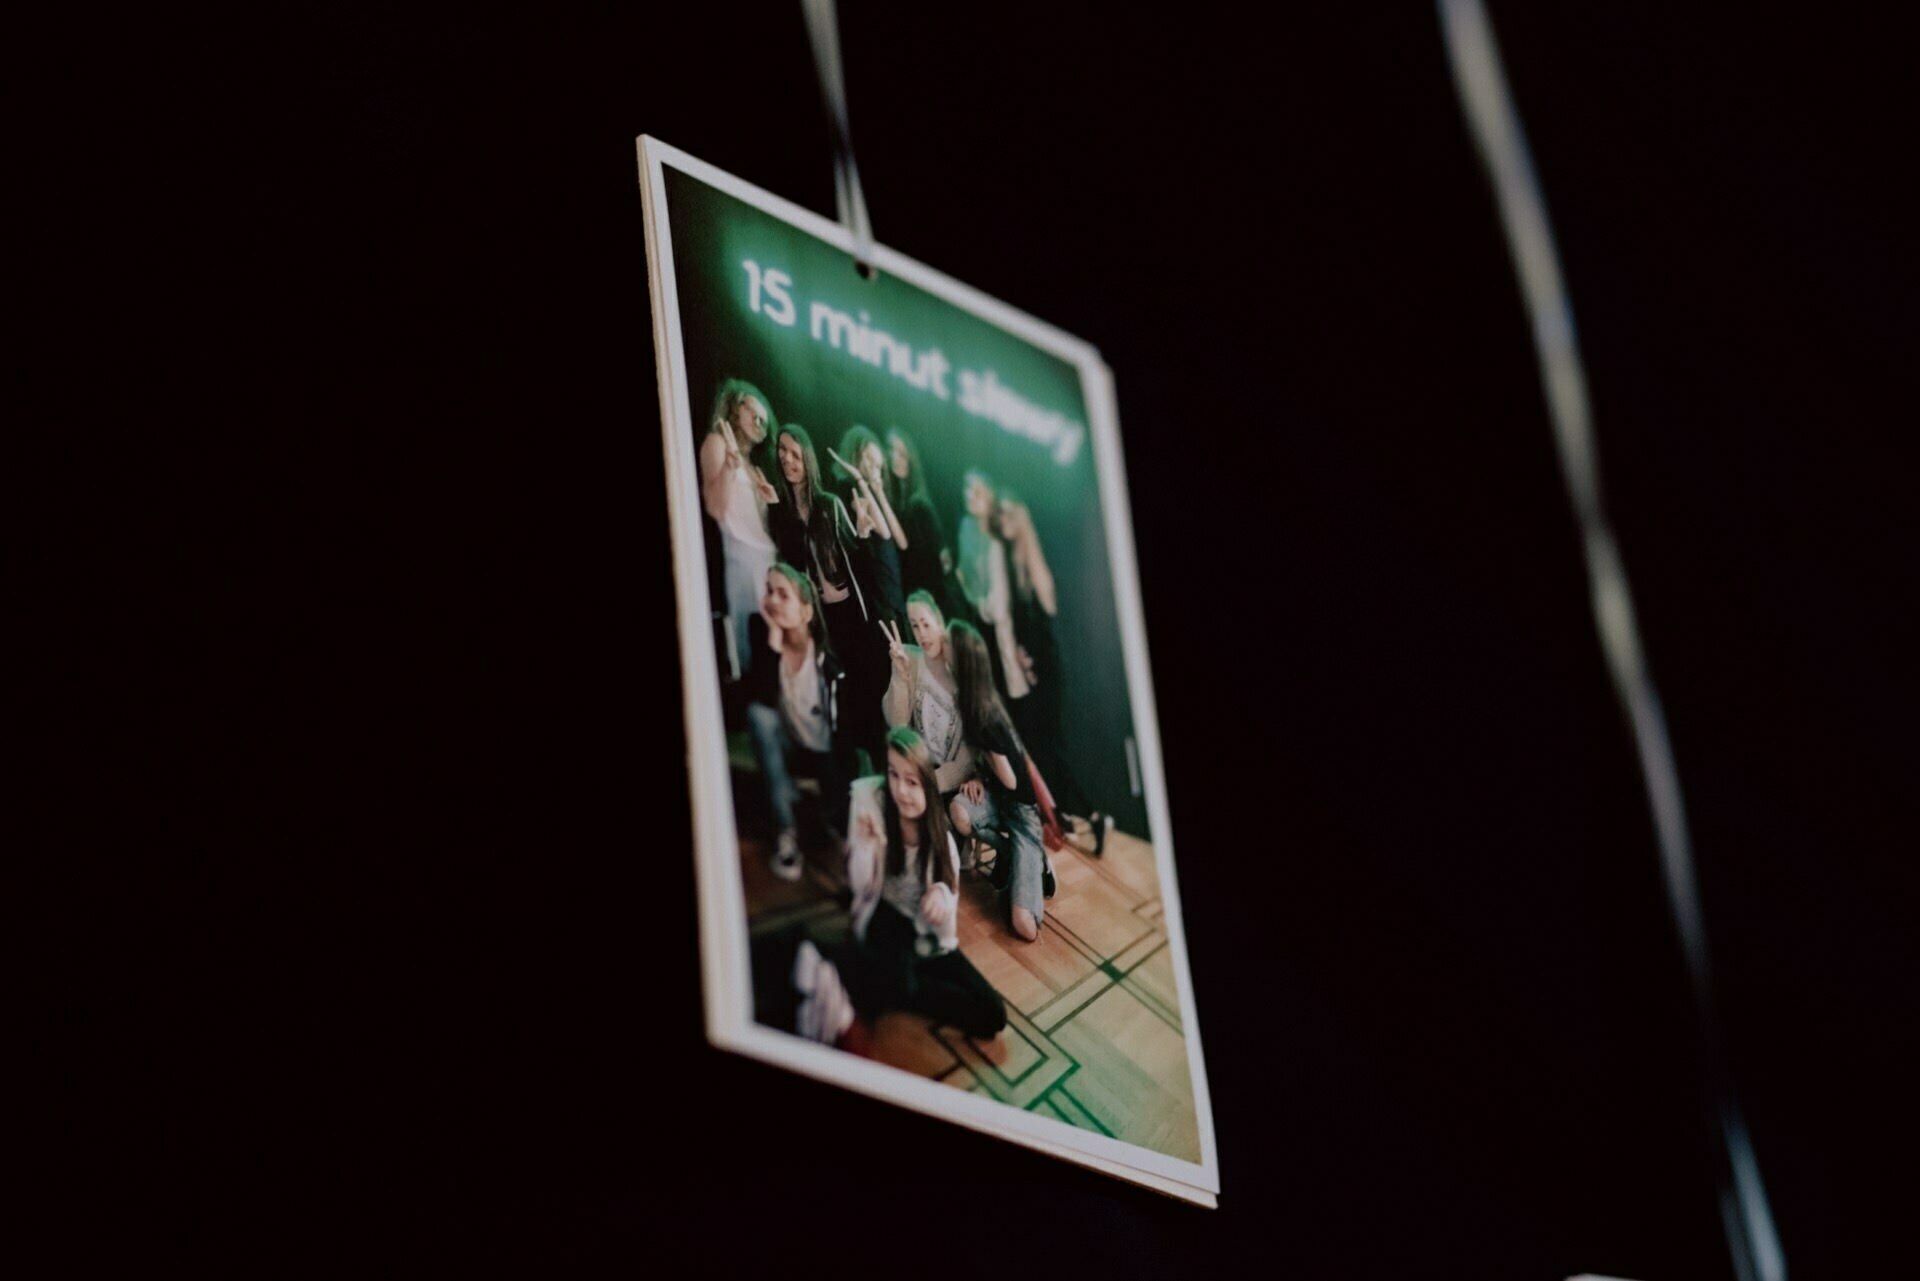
xmin=666 ymin=169 xmax=1148 ymax=835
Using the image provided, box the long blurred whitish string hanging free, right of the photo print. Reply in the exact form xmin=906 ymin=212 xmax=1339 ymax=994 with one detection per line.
xmin=1438 ymin=10 xmax=1788 ymax=1281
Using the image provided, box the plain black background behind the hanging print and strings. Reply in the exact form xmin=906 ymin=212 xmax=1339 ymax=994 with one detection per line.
xmin=74 ymin=0 xmax=1914 ymax=1281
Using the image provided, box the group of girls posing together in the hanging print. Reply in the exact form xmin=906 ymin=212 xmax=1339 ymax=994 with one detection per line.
xmin=699 ymin=378 xmax=1108 ymax=1026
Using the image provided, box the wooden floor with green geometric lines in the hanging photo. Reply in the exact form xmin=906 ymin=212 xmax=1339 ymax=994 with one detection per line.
xmin=733 ymin=755 xmax=1200 ymax=1160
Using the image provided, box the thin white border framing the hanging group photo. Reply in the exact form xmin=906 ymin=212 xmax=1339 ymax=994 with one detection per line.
xmin=637 ymin=134 xmax=1219 ymax=1208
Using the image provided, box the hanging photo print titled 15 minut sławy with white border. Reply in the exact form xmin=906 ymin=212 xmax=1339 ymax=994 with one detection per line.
xmin=639 ymin=138 xmax=1219 ymax=1206
